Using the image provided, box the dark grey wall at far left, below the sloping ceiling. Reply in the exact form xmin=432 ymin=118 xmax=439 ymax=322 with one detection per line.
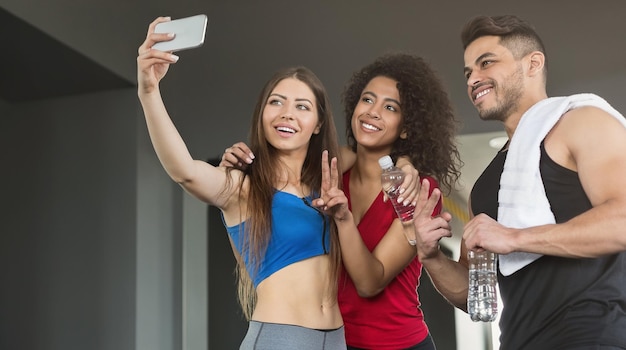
xmin=0 ymin=90 xmax=137 ymax=350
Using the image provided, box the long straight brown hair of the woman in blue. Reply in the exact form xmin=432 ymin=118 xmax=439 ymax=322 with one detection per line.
xmin=237 ymin=67 xmax=341 ymax=319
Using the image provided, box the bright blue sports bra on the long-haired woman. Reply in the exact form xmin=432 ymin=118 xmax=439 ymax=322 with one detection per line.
xmin=222 ymin=190 xmax=330 ymax=288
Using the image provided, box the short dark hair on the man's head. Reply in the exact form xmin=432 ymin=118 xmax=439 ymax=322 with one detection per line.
xmin=461 ymin=15 xmax=547 ymax=65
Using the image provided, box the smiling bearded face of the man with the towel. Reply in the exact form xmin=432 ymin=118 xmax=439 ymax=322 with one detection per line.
xmin=464 ymin=36 xmax=525 ymax=121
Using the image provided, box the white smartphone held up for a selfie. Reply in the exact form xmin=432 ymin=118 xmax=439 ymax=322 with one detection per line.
xmin=152 ymin=15 xmax=209 ymax=51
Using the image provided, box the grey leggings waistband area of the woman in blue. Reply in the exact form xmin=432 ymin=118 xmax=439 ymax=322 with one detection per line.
xmin=239 ymin=321 xmax=346 ymax=350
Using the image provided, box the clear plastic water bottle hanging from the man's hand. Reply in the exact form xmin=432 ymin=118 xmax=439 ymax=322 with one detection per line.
xmin=467 ymin=250 xmax=498 ymax=322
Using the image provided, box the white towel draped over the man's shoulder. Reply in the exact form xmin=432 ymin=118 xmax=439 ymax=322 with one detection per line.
xmin=498 ymin=94 xmax=626 ymax=276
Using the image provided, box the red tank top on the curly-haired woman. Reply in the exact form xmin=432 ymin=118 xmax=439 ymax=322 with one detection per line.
xmin=338 ymin=171 xmax=441 ymax=349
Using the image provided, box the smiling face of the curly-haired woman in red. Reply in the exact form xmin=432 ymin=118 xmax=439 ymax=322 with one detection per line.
xmin=351 ymin=76 xmax=405 ymax=153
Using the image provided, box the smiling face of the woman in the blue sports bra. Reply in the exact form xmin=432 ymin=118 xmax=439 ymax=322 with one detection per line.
xmin=262 ymin=78 xmax=319 ymax=154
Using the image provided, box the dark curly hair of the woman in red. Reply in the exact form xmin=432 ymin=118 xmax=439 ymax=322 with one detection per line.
xmin=342 ymin=53 xmax=462 ymax=193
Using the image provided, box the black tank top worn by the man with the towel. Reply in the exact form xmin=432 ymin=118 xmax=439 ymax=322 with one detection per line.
xmin=470 ymin=143 xmax=626 ymax=350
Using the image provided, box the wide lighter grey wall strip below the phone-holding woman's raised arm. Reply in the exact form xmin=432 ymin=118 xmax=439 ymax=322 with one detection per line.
xmin=136 ymin=118 xmax=183 ymax=350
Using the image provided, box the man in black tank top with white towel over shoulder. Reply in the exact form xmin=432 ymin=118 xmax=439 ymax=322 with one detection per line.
xmin=415 ymin=16 xmax=626 ymax=350
